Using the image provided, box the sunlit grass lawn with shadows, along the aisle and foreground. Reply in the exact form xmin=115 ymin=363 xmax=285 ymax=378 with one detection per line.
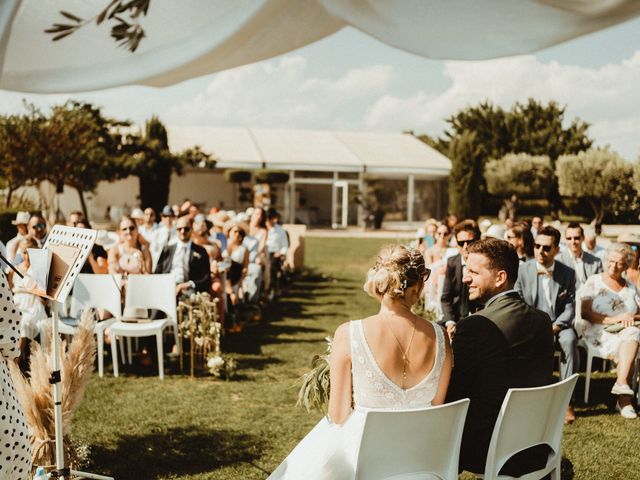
xmin=73 ymin=238 xmax=640 ymax=480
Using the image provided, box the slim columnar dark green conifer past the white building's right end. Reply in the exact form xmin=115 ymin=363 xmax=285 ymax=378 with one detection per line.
xmin=447 ymin=127 xmax=484 ymax=218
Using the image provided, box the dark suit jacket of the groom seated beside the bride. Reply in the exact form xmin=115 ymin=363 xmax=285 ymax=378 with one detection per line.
xmin=447 ymin=292 xmax=554 ymax=475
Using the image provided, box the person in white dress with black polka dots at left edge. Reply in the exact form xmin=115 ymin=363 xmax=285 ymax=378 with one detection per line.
xmin=0 ymin=272 xmax=31 ymax=480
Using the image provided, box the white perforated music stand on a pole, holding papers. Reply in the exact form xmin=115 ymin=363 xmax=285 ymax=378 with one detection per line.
xmin=41 ymin=225 xmax=114 ymax=480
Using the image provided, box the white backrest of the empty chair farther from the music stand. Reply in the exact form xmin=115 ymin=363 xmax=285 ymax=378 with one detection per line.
xmin=125 ymin=273 xmax=178 ymax=325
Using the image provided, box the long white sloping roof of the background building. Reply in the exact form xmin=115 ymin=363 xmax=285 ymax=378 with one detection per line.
xmin=167 ymin=127 xmax=451 ymax=178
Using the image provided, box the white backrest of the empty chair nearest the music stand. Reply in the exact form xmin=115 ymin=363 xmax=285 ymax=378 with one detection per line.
xmin=70 ymin=273 xmax=122 ymax=319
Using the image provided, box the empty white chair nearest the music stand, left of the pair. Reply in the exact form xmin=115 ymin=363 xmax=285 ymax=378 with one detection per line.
xmin=41 ymin=273 xmax=122 ymax=377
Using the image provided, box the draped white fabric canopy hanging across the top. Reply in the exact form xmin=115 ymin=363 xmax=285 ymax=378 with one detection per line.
xmin=0 ymin=0 xmax=640 ymax=93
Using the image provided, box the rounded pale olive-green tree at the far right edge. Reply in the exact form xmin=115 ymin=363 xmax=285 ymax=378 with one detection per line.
xmin=556 ymin=150 xmax=638 ymax=229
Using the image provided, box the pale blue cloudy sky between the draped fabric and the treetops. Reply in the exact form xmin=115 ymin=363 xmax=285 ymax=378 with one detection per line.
xmin=0 ymin=19 xmax=640 ymax=160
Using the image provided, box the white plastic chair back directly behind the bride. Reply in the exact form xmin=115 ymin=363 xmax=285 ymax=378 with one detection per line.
xmin=355 ymin=398 xmax=469 ymax=480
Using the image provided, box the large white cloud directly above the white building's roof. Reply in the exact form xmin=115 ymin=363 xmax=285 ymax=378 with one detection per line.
xmin=162 ymin=56 xmax=393 ymax=128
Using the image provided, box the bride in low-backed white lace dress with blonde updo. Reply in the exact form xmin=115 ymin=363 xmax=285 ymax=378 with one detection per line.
xmin=269 ymin=245 xmax=452 ymax=480
